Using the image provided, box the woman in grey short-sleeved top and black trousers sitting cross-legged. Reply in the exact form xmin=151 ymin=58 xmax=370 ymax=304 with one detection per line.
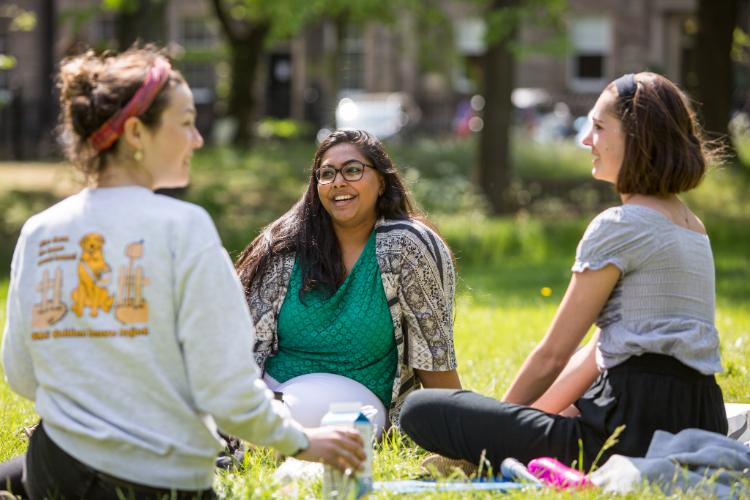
xmin=401 ymin=73 xmax=727 ymax=470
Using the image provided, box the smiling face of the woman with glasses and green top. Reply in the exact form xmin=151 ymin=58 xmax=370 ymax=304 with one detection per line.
xmin=317 ymin=143 xmax=385 ymax=229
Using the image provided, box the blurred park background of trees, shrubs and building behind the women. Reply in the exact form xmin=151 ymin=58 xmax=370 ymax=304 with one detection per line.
xmin=0 ymin=0 xmax=750 ymax=266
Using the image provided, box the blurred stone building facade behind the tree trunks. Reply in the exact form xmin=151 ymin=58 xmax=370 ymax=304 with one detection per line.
xmin=0 ymin=0 xmax=740 ymax=159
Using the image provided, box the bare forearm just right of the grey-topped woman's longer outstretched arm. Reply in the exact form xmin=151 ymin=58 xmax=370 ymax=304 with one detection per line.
xmin=531 ymin=330 xmax=599 ymax=413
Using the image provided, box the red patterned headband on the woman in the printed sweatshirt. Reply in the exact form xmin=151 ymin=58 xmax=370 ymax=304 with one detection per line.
xmin=89 ymin=57 xmax=172 ymax=151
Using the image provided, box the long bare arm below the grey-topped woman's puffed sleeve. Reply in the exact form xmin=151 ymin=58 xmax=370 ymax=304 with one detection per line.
xmin=503 ymin=264 xmax=620 ymax=405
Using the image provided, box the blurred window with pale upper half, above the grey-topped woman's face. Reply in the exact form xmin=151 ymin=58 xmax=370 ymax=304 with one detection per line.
xmin=568 ymin=17 xmax=612 ymax=92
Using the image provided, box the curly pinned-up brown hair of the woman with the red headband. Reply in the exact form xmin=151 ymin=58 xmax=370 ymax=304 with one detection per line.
xmin=58 ymin=45 xmax=185 ymax=177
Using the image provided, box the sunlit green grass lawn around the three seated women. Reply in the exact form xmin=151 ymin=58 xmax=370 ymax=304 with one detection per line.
xmin=0 ymin=227 xmax=750 ymax=498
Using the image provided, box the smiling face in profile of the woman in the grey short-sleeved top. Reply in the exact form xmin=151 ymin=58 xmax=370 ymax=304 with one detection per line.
xmin=582 ymin=89 xmax=625 ymax=184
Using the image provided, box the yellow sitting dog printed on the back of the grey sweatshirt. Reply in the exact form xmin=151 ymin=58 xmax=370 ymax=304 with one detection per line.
xmin=70 ymin=233 xmax=114 ymax=317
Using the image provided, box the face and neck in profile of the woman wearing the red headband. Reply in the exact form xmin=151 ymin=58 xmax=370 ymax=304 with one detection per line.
xmin=143 ymin=83 xmax=203 ymax=189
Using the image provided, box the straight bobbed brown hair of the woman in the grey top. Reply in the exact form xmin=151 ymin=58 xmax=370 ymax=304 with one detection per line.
xmin=606 ymin=72 xmax=712 ymax=196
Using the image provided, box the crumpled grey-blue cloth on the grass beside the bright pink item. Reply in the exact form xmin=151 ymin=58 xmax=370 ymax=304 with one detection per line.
xmin=591 ymin=429 xmax=750 ymax=499
